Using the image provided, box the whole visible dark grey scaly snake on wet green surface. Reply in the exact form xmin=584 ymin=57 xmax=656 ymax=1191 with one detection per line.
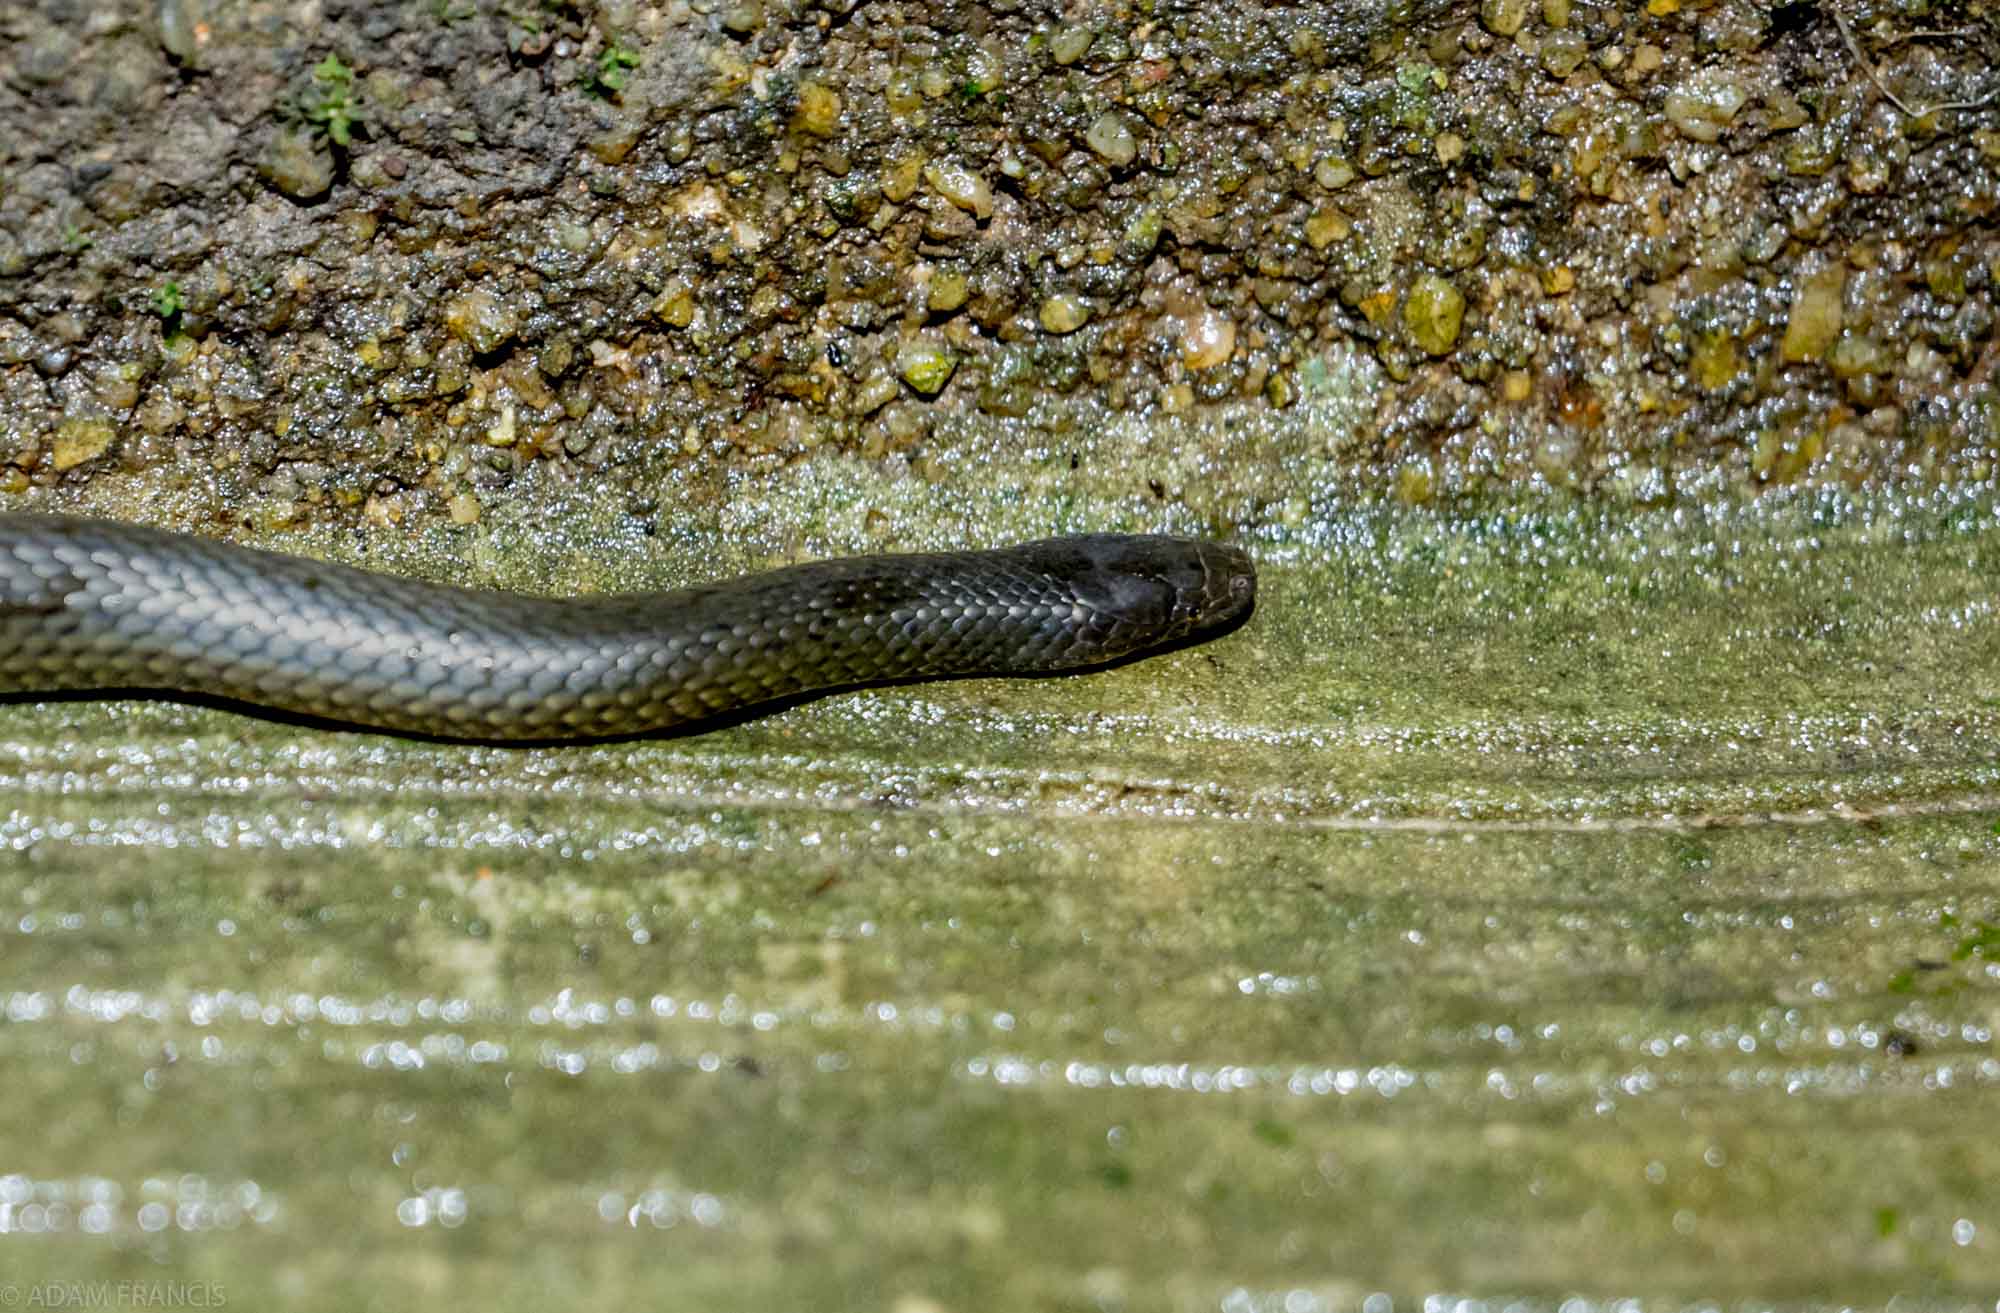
xmin=0 ymin=512 xmax=1256 ymax=743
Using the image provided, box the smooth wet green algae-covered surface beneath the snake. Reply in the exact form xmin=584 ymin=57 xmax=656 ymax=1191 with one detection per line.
xmin=0 ymin=478 xmax=2000 ymax=1313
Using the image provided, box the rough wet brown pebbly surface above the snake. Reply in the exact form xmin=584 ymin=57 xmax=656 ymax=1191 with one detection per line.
xmin=0 ymin=0 xmax=2000 ymax=526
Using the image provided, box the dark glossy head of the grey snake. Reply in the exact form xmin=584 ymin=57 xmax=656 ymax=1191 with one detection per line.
xmin=1064 ymin=534 xmax=1256 ymax=661
